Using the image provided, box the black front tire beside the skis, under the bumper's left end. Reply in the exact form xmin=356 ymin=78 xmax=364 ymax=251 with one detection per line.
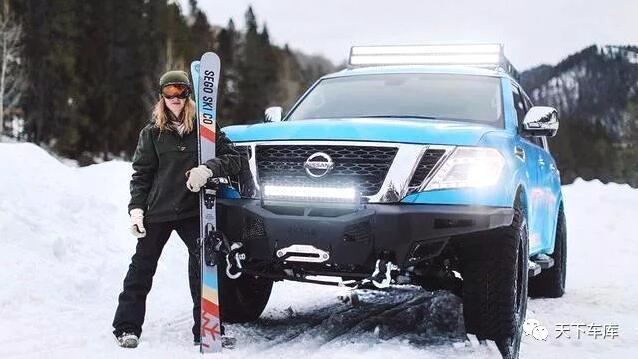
xmin=219 ymin=266 xmax=273 ymax=323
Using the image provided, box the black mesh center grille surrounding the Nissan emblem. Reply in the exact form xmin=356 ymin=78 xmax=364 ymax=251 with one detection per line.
xmin=257 ymin=145 xmax=398 ymax=196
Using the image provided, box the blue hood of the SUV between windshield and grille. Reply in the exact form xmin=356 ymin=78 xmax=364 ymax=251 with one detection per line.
xmin=224 ymin=118 xmax=499 ymax=146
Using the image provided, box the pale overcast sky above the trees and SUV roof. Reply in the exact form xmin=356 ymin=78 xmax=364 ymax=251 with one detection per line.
xmin=190 ymin=0 xmax=638 ymax=70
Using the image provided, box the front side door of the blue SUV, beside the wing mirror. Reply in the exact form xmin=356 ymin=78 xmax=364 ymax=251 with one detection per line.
xmin=512 ymin=83 xmax=545 ymax=253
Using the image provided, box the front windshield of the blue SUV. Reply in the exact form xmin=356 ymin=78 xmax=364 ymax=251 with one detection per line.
xmin=287 ymin=74 xmax=503 ymax=126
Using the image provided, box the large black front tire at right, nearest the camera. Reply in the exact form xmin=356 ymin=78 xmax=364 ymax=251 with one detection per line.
xmin=461 ymin=206 xmax=529 ymax=358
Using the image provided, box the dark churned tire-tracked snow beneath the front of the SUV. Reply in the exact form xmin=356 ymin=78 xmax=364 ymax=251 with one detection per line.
xmin=229 ymin=288 xmax=466 ymax=351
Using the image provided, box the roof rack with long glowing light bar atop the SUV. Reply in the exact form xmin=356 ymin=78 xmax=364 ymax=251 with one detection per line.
xmin=348 ymin=44 xmax=519 ymax=79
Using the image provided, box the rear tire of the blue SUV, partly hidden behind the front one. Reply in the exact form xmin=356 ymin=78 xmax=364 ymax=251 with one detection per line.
xmin=529 ymin=204 xmax=567 ymax=298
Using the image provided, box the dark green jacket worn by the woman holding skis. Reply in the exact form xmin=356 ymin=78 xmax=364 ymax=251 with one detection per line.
xmin=128 ymin=123 xmax=241 ymax=222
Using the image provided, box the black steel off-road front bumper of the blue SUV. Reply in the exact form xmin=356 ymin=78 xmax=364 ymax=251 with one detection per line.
xmin=217 ymin=198 xmax=514 ymax=273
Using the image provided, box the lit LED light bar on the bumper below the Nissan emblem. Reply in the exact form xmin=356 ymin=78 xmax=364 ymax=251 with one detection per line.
xmin=263 ymin=184 xmax=357 ymax=203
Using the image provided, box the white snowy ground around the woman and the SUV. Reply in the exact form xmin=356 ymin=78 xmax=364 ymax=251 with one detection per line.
xmin=0 ymin=143 xmax=638 ymax=359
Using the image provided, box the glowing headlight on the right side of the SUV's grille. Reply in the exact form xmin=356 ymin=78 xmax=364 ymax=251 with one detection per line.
xmin=425 ymin=147 xmax=505 ymax=191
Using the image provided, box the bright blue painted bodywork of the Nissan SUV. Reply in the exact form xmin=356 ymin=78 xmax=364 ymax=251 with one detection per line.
xmin=224 ymin=66 xmax=562 ymax=255
